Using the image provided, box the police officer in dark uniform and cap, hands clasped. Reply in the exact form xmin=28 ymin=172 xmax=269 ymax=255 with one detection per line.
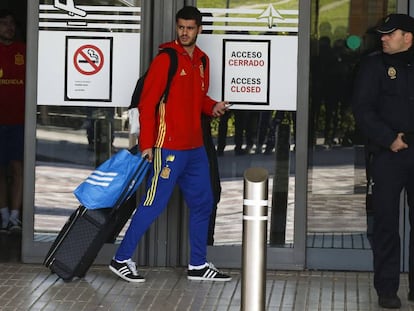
xmin=352 ymin=14 xmax=414 ymax=309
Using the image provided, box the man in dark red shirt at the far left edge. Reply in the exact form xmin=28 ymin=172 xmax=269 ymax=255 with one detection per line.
xmin=0 ymin=9 xmax=26 ymax=232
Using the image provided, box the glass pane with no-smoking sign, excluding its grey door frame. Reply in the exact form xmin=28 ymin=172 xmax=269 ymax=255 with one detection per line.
xmin=34 ymin=0 xmax=141 ymax=240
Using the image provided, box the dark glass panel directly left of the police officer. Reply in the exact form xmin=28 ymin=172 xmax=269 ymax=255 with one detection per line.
xmin=306 ymin=0 xmax=397 ymax=270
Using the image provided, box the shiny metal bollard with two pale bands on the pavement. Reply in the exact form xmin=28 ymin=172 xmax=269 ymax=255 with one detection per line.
xmin=241 ymin=168 xmax=269 ymax=311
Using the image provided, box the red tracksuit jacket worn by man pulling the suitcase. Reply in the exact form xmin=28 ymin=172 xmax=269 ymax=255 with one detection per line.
xmin=138 ymin=41 xmax=216 ymax=150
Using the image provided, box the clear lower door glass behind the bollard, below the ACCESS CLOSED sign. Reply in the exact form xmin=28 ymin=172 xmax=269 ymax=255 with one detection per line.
xmin=213 ymin=110 xmax=295 ymax=246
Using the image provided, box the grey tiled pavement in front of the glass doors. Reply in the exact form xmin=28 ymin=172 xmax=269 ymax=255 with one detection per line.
xmin=0 ymin=263 xmax=414 ymax=311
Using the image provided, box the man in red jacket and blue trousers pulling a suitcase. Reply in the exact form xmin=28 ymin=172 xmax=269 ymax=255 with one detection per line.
xmin=109 ymin=6 xmax=231 ymax=282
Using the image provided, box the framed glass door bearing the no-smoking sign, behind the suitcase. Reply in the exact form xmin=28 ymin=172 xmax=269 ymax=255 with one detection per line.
xmin=23 ymin=0 xmax=141 ymax=262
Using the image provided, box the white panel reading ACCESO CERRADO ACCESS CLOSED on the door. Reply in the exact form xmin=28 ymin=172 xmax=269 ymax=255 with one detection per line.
xmin=197 ymin=34 xmax=298 ymax=111
